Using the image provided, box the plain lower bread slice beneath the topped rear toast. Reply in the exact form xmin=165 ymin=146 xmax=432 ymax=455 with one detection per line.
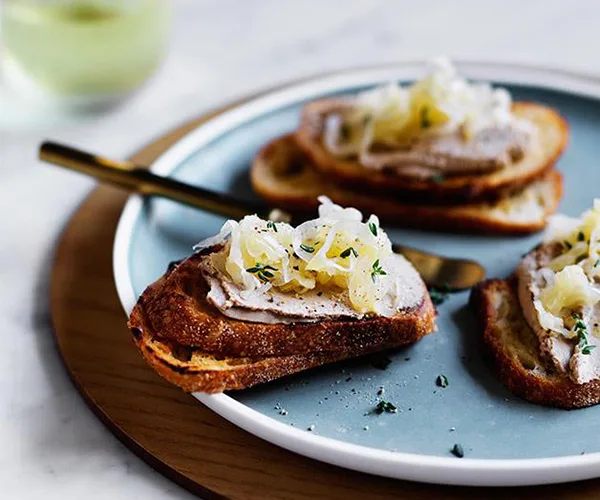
xmin=250 ymin=135 xmax=562 ymax=234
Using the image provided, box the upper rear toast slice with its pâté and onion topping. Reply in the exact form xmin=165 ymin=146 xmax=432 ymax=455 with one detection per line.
xmin=294 ymin=59 xmax=569 ymax=207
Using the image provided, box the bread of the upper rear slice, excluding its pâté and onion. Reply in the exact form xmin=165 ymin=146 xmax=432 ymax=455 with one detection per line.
xmin=296 ymin=100 xmax=569 ymax=203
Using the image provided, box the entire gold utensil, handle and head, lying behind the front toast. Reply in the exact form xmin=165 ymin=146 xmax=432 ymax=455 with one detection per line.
xmin=39 ymin=142 xmax=485 ymax=290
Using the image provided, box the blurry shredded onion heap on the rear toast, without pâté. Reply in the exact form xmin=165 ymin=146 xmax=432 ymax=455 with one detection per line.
xmin=323 ymin=58 xmax=533 ymax=157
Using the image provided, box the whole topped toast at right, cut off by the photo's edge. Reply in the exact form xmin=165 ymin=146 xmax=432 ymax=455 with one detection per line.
xmin=471 ymin=200 xmax=600 ymax=409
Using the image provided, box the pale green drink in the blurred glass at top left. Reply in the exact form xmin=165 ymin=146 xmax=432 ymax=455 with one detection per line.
xmin=0 ymin=0 xmax=170 ymax=95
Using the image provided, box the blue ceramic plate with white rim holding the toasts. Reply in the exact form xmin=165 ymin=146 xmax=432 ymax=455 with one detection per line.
xmin=114 ymin=64 xmax=600 ymax=485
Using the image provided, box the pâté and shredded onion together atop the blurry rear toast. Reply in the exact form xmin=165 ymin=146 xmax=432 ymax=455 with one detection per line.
xmin=305 ymin=59 xmax=536 ymax=179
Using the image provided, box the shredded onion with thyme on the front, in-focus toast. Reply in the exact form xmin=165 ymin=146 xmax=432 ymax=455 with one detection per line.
xmin=195 ymin=196 xmax=410 ymax=316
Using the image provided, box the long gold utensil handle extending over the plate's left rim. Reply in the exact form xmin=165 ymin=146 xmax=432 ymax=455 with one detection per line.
xmin=39 ymin=142 xmax=289 ymax=220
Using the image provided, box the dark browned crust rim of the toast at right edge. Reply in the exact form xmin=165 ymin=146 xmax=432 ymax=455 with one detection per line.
xmin=470 ymin=279 xmax=600 ymax=409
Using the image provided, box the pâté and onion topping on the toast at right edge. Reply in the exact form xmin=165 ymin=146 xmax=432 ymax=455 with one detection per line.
xmin=517 ymin=200 xmax=600 ymax=384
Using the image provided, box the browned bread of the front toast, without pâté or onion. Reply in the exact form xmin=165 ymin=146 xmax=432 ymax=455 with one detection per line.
xmin=129 ymin=254 xmax=436 ymax=393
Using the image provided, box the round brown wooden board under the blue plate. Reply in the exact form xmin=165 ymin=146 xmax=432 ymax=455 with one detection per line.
xmin=50 ymin=113 xmax=600 ymax=500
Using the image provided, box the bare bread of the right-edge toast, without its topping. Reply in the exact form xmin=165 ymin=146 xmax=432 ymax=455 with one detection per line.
xmin=470 ymin=279 xmax=600 ymax=409
